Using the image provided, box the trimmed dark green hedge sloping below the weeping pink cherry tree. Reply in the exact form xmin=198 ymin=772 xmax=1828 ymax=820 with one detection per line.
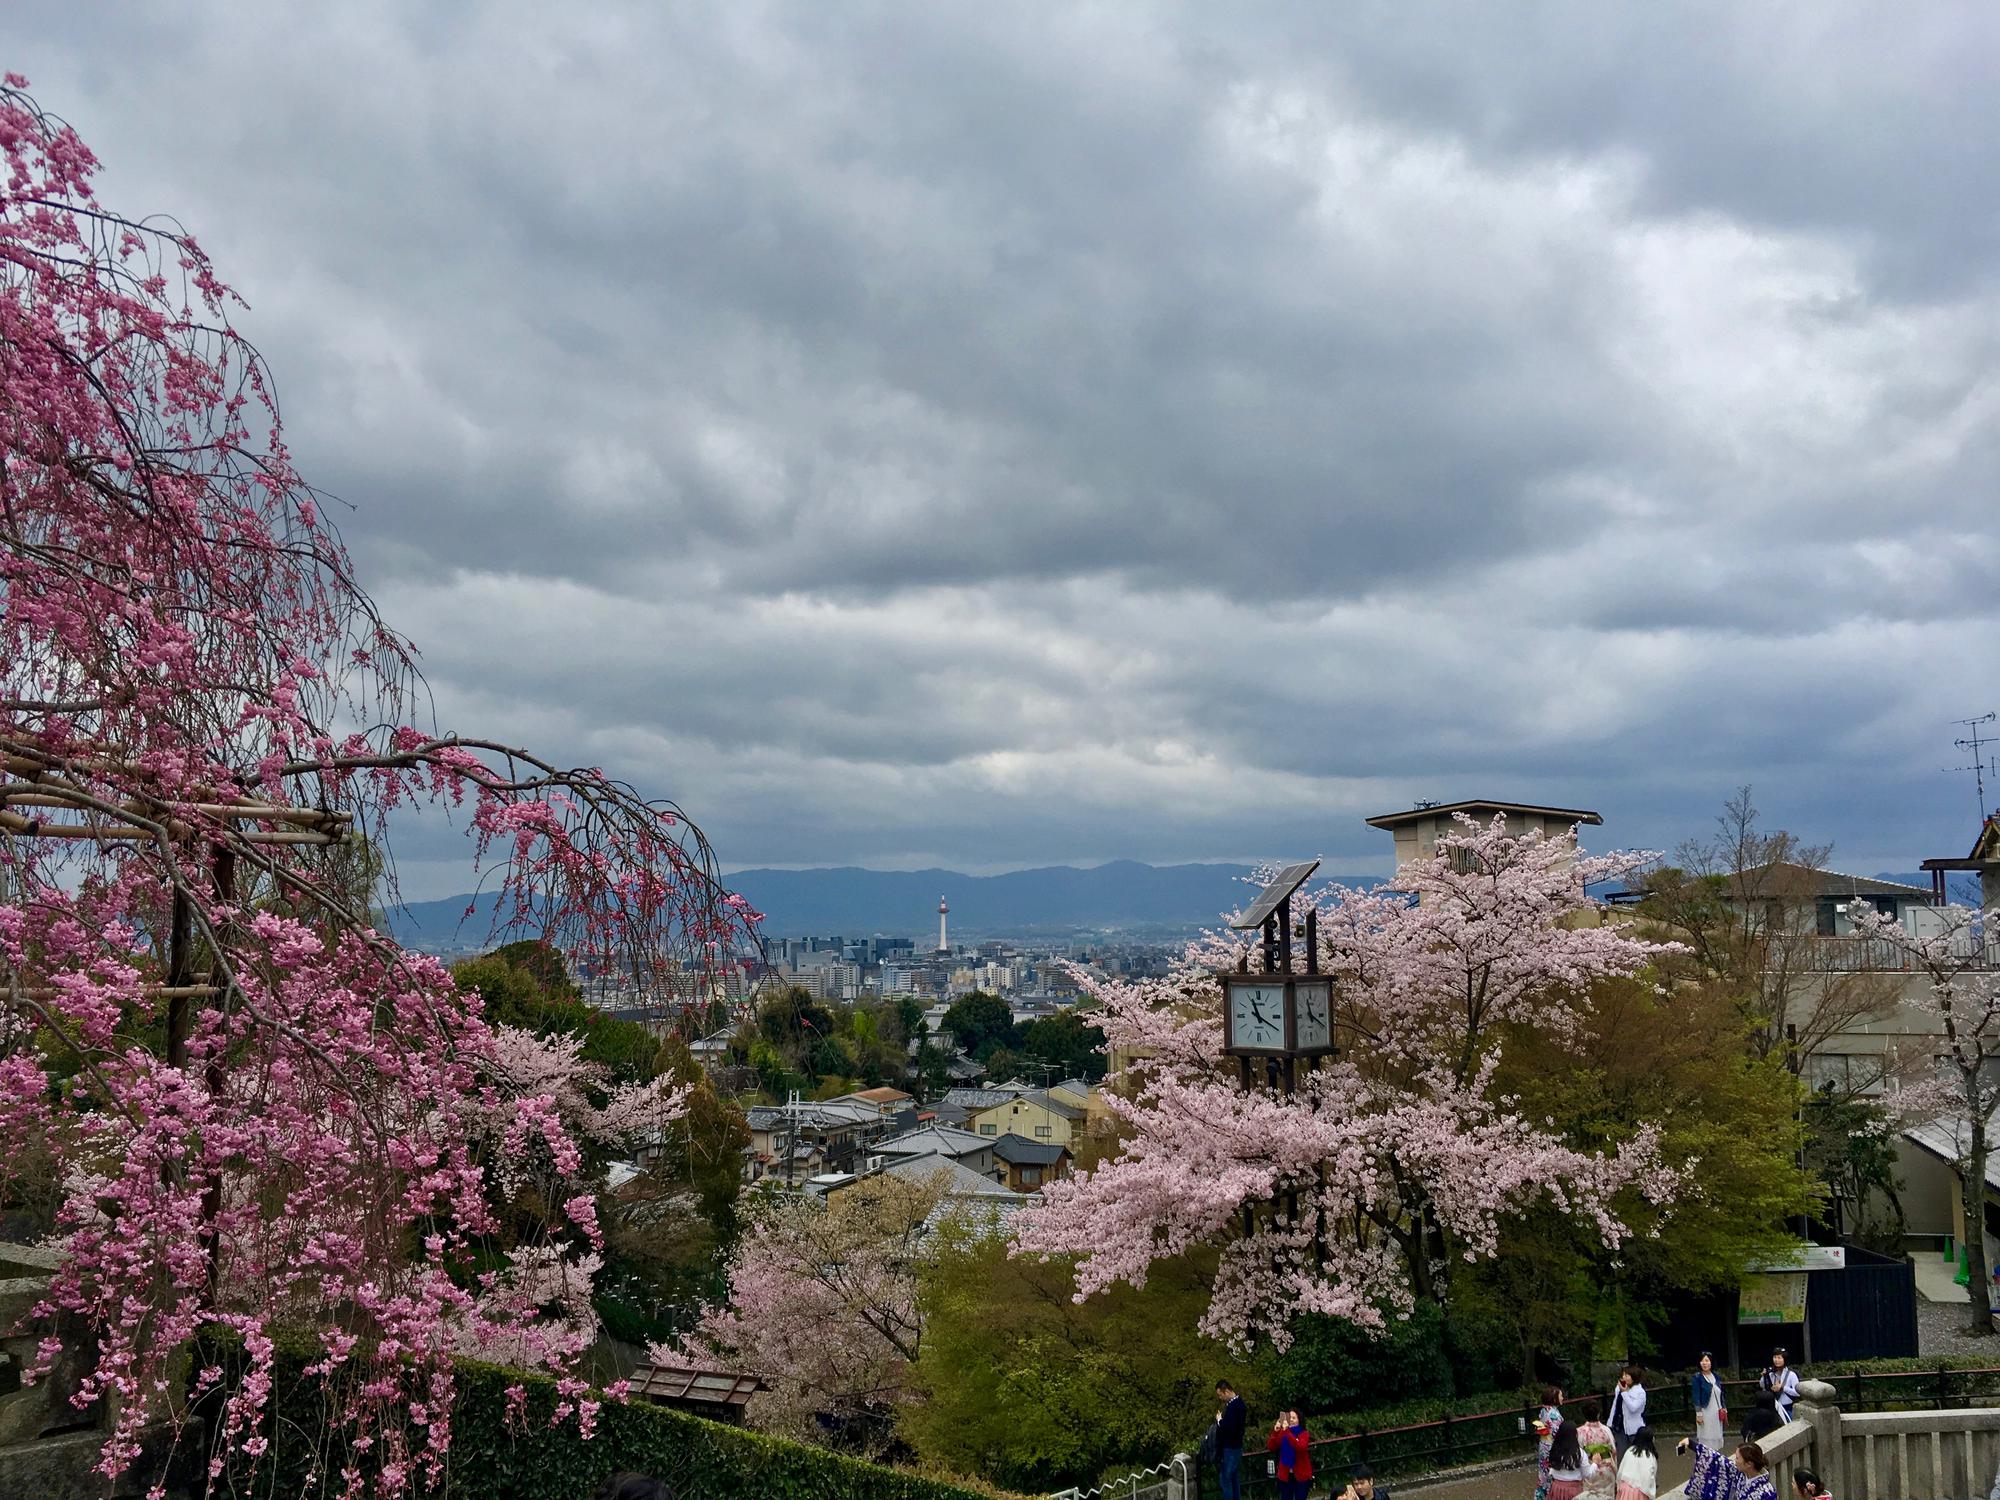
xmin=198 ymin=1338 xmax=982 ymax=1500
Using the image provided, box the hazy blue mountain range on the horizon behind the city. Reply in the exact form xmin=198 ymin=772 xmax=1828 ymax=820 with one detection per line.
xmin=378 ymin=860 xmax=1380 ymax=950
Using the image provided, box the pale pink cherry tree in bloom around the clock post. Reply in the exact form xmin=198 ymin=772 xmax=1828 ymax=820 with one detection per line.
xmin=1016 ymin=818 xmax=1676 ymax=1348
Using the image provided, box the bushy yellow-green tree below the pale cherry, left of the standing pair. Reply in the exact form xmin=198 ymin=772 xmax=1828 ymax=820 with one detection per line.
xmin=898 ymin=1222 xmax=1266 ymax=1492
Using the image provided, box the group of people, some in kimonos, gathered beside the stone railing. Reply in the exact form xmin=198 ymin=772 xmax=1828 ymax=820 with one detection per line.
xmin=1534 ymin=1348 xmax=1832 ymax=1500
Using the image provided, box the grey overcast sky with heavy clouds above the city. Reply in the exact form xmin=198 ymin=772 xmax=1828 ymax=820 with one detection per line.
xmin=15 ymin=0 xmax=2000 ymax=896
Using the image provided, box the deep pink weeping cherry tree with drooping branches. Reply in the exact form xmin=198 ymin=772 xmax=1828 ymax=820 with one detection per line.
xmin=0 ymin=74 xmax=750 ymax=1494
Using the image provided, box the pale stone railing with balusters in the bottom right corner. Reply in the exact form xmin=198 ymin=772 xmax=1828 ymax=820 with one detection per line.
xmin=1660 ymin=1380 xmax=2000 ymax=1500
